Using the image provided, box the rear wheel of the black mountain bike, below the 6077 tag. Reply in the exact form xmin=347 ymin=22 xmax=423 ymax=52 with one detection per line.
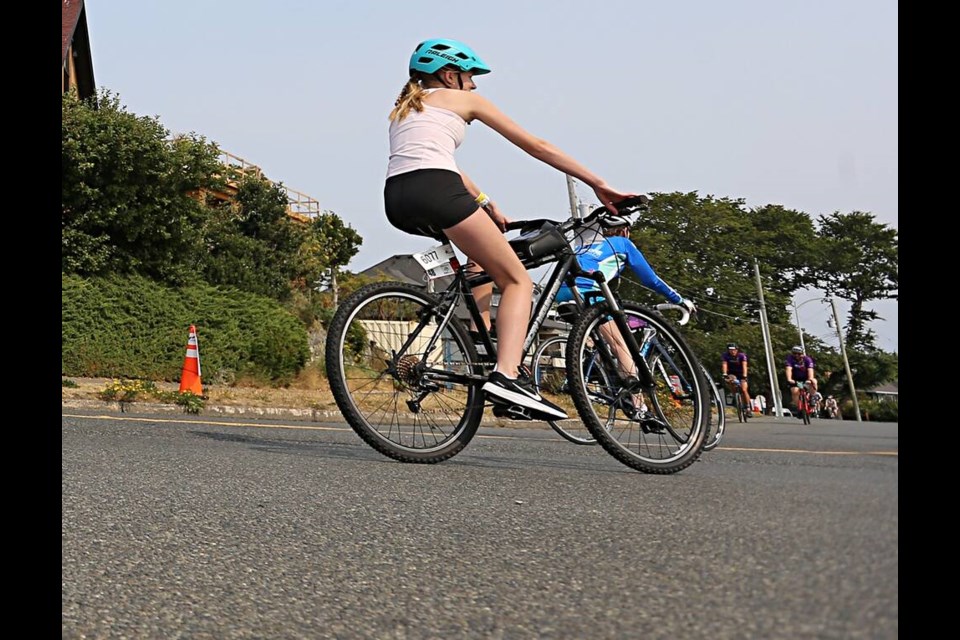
xmin=326 ymin=282 xmax=483 ymax=463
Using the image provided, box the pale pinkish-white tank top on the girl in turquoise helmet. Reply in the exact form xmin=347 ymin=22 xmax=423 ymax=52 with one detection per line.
xmin=387 ymin=89 xmax=467 ymax=178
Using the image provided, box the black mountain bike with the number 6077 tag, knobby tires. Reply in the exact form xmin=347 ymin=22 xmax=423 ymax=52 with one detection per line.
xmin=326 ymin=196 xmax=709 ymax=474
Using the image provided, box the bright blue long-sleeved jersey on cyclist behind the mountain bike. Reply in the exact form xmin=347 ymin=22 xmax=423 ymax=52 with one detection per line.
xmin=557 ymin=236 xmax=683 ymax=304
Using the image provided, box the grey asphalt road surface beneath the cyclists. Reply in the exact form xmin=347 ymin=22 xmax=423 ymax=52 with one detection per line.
xmin=61 ymin=407 xmax=899 ymax=640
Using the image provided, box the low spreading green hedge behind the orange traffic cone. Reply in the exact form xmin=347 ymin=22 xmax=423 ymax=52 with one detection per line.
xmin=61 ymin=275 xmax=309 ymax=384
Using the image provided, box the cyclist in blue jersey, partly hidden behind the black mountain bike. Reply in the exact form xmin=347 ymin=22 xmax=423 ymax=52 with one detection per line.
xmin=557 ymin=216 xmax=697 ymax=420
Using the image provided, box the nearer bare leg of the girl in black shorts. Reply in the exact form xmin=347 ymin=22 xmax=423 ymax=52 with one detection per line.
xmin=444 ymin=209 xmax=533 ymax=377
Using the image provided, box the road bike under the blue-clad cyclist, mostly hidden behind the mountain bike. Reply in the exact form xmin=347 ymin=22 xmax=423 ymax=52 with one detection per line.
xmin=532 ymin=303 xmax=726 ymax=451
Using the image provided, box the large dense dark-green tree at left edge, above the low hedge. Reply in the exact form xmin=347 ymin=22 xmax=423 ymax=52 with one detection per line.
xmin=61 ymin=90 xmax=219 ymax=282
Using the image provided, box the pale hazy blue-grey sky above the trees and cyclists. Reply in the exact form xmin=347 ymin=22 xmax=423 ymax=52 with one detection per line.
xmin=85 ymin=0 xmax=899 ymax=351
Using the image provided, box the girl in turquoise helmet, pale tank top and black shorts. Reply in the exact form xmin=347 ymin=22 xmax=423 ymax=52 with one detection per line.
xmin=384 ymin=39 xmax=634 ymax=419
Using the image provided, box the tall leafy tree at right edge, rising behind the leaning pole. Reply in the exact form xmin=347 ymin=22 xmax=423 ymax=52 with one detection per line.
xmin=816 ymin=211 xmax=900 ymax=350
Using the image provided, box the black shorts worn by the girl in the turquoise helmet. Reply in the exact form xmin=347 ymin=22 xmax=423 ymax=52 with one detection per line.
xmin=383 ymin=169 xmax=480 ymax=242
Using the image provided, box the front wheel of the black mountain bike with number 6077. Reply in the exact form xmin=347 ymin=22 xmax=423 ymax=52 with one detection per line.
xmin=567 ymin=301 xmax=710 ymax=474
